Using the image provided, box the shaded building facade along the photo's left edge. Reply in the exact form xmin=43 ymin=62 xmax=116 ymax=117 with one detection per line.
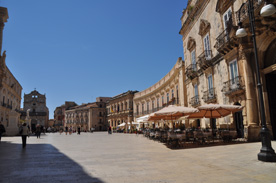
xmin=0 ymin=7 xmax=22 ymax=135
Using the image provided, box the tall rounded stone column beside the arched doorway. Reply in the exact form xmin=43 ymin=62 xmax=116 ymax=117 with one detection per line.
xmin=241 ymin=49 xmax=260 ymax=141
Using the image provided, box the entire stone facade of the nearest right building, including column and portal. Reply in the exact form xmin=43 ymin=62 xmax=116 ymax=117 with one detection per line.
xmin=180 ymin=0 xmax=276 ymax=141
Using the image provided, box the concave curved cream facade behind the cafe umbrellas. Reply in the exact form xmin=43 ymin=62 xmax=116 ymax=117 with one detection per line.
xmin=133 ymin=57 xmax=187 ymax=126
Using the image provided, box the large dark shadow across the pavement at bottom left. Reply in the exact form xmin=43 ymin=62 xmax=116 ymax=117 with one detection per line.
xmin=0 ymin=141 xmax=103 ymax=183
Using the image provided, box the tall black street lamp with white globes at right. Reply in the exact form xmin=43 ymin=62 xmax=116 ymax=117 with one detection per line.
xmin=236 ymin=0 xmax=276 ymax=162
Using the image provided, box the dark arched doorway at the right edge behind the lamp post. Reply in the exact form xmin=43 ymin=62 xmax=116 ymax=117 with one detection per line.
xmin=264 ymin=39 xmax=276 ymax=140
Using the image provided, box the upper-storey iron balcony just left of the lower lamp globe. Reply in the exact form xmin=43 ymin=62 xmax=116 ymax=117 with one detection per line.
xmin=215 ymin=18 xmax=239 ymax=55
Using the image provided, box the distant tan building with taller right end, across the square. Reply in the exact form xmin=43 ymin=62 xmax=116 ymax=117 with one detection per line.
xmin=64 ymin=97 xmax=110 ymax=131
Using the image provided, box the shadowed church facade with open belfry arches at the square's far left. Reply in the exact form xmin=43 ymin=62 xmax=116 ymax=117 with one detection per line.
xmin=21 ymin=90 xmax=49 ymax=132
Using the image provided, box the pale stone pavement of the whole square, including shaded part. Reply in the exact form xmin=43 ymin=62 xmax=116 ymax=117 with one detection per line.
xmin=0 ymin=132 xmax=276 ymax=183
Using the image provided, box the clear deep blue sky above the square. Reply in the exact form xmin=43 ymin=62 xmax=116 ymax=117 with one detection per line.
xmin=0 ymin=0 xmax=187 ymax=118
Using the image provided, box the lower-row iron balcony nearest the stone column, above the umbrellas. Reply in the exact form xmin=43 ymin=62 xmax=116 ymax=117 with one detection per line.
xmin=222 ymin=76 xmax=244 ymax=96
